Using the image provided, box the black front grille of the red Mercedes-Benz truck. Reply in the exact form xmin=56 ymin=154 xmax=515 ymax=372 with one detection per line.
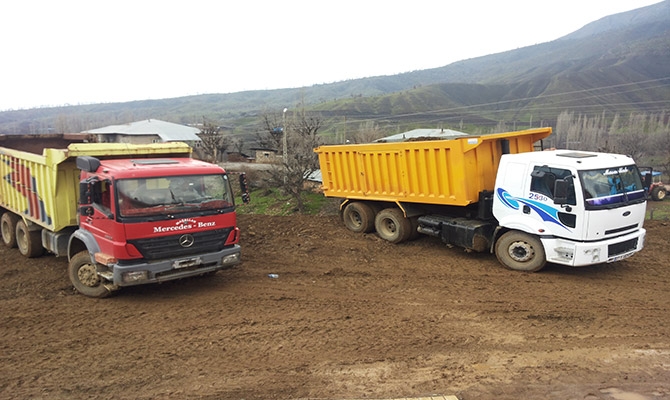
xmin=128 ymin=228 xmax=232 ymax=261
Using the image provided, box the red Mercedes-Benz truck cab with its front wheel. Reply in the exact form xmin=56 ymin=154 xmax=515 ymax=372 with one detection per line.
xmin=68 ymin=156 xmax=240 ymax=297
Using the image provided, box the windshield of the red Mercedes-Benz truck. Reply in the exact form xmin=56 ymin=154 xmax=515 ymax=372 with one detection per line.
xmin=116 ymin=175 xmax=234 ymax=217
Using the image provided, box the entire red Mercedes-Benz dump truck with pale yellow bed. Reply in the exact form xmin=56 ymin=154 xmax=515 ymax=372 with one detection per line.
xmin=0 ymin=143 xmax=247 ymax=297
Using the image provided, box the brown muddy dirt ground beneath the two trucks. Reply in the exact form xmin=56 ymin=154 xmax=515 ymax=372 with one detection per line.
xmin=0 ymin=206 xmax=670 ymax=400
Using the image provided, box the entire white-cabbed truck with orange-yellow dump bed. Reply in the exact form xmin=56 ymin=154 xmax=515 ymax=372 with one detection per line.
xmin=315 ymin=128 xmax=646 ymax=271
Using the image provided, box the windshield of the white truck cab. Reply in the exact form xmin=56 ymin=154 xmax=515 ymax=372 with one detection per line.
xmin=579 ymin=165 xmax=646 ymax=209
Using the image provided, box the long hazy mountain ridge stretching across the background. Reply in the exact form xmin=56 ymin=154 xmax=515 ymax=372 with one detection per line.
xmin=0 ymin=0 xmax=670 ymax=134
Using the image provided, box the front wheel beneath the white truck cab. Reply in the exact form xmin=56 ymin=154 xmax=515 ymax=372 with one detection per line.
xmin=495 ymin=231 xmax=547 ymax=272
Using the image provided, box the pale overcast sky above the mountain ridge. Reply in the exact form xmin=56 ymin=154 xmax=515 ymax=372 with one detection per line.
xmin=0 ymin=0 xmax=660 ymax=110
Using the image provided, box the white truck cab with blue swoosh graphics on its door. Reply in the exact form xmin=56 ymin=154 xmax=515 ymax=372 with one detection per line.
xmin=493 ymin=150 xmax=646 ymax=266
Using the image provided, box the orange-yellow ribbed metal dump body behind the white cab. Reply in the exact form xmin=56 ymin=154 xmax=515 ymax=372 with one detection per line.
xmin=315 ymin=128 xmax=551 ymax=206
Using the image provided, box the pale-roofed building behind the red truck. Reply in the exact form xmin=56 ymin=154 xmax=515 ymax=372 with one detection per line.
xmin=82 ymin=119 xmax=202 ymax=148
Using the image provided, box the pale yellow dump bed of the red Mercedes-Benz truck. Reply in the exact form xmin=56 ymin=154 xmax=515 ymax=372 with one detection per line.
xmin=0 ymin=143 xmax=192 ymax=232
